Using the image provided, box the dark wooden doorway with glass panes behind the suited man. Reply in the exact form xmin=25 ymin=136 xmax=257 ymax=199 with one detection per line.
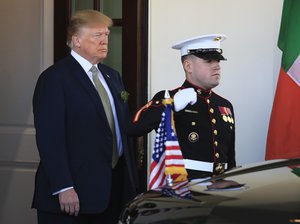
xmin=54 ymin=0 xmax=148 ymax=191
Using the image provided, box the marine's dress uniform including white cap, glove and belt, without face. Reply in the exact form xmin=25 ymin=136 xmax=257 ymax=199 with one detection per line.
xmin=129 ymin=35 xmax=236 ymax=179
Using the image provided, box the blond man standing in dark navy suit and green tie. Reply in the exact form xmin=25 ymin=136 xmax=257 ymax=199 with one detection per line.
xmin=32 ymin=10 xmax=136 ymax=224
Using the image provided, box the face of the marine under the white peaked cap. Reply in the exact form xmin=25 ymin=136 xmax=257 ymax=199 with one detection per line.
xmin=184 ymin=56 xmax=221 ymax=90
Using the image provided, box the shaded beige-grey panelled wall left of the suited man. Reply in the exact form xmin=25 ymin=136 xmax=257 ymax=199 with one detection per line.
xmin=0 ymin=0 xmax=53 ymax=224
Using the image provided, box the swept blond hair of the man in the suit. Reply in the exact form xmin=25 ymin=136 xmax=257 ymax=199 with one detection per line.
xmin=67 ymin=9 xmax=113 ymax=49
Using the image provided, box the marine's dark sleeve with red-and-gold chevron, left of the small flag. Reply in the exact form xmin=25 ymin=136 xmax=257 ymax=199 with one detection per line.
xmin=127 ymin=91 xmax=165 ymax=137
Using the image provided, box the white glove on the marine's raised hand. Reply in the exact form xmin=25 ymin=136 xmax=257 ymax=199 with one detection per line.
xmin=174 ymin=88 xmax=197 ymax=112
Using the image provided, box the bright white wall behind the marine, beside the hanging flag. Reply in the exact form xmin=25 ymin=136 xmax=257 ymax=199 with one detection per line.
xmin=149 ymin=0 xmax=283 ymax=164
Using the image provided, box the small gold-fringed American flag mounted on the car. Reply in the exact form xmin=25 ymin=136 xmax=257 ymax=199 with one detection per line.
xmin=149 ymin=99 xmax=191 ymax=197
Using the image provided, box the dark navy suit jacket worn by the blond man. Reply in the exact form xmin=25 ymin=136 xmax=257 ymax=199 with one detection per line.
xmin=32 ymin=55 xmax=136 ymax=213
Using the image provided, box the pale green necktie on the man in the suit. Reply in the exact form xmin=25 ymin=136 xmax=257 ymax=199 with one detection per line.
xmin=90 ymin=65 xmax=119 ymax=168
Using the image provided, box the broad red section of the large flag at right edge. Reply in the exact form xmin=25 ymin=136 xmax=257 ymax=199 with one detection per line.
xmin=266 ymin=69 xmax=300 ymax=160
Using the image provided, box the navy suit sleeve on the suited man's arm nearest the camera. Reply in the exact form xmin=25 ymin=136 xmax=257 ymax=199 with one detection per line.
xmin=33 ymin=70 xmax=73 ymax=194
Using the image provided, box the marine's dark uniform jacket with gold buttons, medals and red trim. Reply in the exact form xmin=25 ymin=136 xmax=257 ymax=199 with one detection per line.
xmin=128 ymin=80 xmax=236 ymax=178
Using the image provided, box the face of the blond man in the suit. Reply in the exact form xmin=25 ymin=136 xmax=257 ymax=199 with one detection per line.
xmin=72 ymin=25 xmax=109 ymax=64
